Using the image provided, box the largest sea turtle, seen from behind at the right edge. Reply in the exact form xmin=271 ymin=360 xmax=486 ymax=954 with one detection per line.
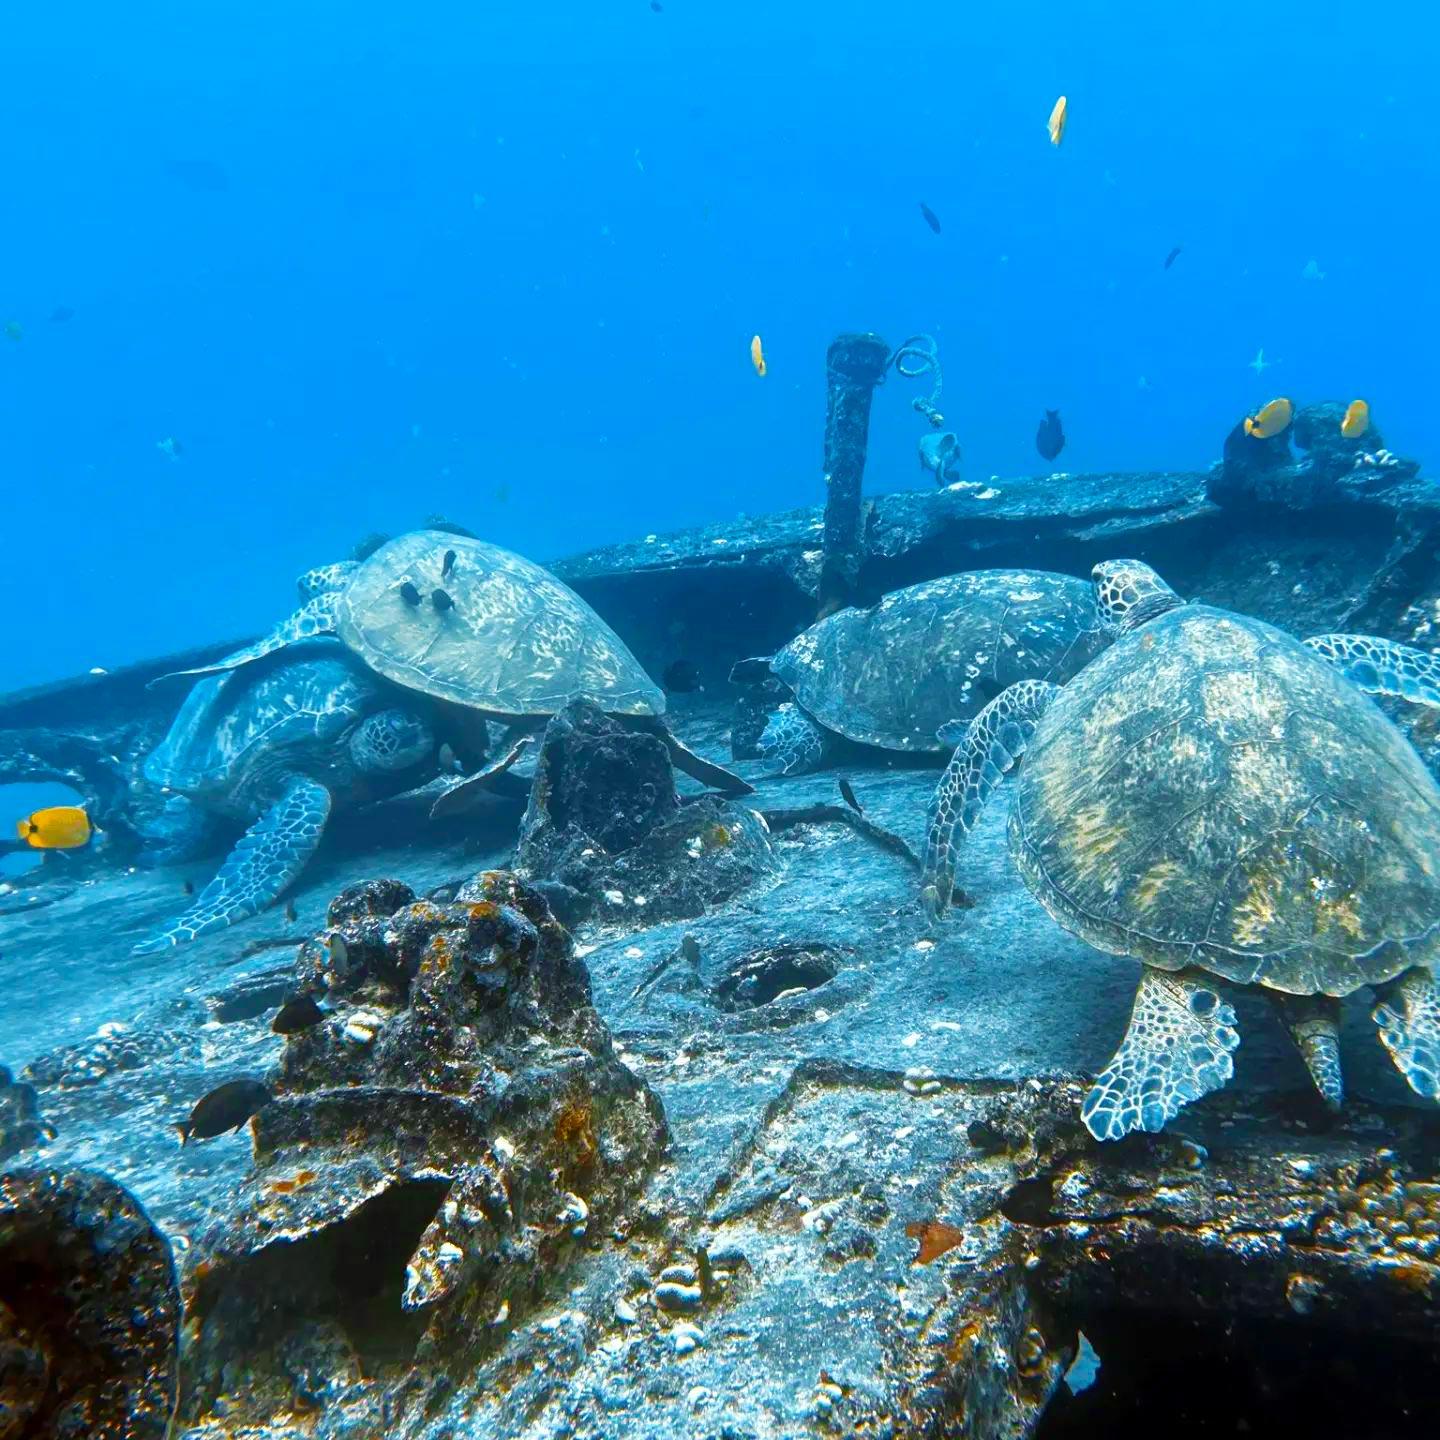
xmin=923 ymin=560 xmax=1440 ymax=1140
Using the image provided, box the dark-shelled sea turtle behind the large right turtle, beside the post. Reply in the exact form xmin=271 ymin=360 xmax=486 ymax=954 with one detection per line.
xmin=730 ymin=570 xmax=1110 ymax=775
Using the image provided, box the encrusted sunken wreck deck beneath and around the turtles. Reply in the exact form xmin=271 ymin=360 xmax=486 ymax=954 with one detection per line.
xmin=0 ymin=474 xmax=1440 ymax=1440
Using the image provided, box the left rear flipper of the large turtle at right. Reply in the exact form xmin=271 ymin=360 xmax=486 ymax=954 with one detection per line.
xmin=1080 ymin=968 xmax=1240 ymax=1140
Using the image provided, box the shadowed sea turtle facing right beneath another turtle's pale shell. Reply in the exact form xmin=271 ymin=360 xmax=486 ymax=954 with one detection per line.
xmin=135 ymin=638 xmax=436 ymax=955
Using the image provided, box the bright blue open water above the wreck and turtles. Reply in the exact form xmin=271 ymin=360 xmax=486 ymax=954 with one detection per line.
xmin=0 ymin=0 xmax=1440 ymax=688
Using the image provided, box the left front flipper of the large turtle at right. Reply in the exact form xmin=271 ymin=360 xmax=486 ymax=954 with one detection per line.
xmin=920 ymin=680 xmax=1060 ymax=917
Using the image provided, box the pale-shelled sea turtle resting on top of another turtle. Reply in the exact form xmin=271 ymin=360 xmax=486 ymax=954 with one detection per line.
xmin=163 ymin=530 xmax=750 ymax=793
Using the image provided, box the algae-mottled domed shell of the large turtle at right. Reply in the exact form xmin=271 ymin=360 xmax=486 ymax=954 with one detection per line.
xmin=1009 ymin=605 xmax=1440 ymax=995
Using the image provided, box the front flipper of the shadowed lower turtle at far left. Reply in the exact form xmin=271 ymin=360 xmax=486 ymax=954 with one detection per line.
xmin=131 ymin=776 xmax=330 ymax=955
